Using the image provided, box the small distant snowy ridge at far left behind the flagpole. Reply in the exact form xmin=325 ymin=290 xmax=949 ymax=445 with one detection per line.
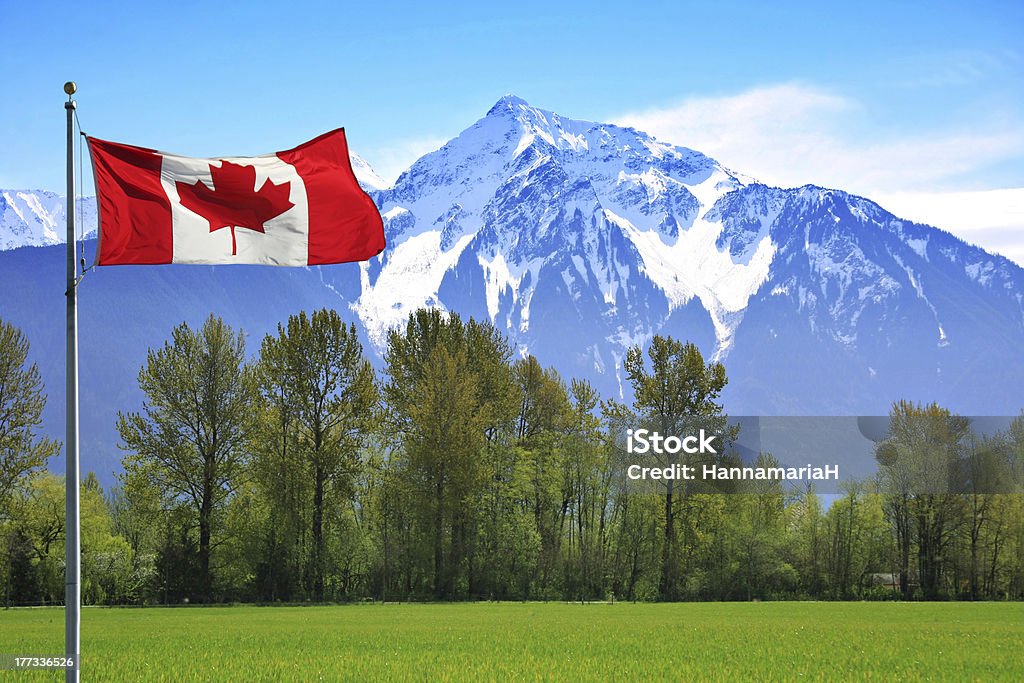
xmin=0 ymin=189 xmax=96 ymax=251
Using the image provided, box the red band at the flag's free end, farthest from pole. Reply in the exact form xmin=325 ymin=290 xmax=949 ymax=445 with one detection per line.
xmin=278 ymin=128 xmax=384 ymax=265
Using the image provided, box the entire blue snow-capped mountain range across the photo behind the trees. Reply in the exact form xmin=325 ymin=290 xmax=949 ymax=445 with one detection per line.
xmin=0 ymin=96 xmax=1024 ymax=481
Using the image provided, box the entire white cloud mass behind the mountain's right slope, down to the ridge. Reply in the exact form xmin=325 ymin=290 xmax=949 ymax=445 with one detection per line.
xmin=616 ymin=83 xmax=1024 ymax=264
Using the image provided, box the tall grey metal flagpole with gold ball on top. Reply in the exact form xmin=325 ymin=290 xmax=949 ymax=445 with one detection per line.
xmin=65 ymin=81 xmax=82 ymax=683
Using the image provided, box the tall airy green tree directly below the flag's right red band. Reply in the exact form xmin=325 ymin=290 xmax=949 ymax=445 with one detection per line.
xmin=254 ymin=309 xmax=378 ymax=600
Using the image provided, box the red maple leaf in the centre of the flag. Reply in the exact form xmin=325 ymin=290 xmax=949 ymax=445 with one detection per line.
xmin=175 ymin=161 xmax=295 ymax=256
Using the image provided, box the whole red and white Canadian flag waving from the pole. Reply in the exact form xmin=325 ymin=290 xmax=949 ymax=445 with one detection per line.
xmin=88 ymin=129 xmax=384 ymax=265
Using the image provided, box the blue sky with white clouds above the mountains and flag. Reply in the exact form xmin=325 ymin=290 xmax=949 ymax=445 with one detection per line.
xmin=6 ymin=2 xmax=1024 ymax=262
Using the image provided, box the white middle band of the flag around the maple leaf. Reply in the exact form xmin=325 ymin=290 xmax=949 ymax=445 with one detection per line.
xmin=160 ymin=154 xmax=309 ymax=266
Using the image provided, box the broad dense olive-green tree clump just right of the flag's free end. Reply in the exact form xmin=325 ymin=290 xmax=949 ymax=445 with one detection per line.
xmin=384 ymin=310 xmax=515 ymax=597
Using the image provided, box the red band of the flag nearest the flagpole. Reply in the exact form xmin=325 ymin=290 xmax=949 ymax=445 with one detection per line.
xmin=88 ymin=137 xmax=174 ymax=265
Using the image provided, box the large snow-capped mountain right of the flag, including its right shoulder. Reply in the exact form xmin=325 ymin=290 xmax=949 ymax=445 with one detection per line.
xmin=354 ymin=95 xmax=1024 ymax=414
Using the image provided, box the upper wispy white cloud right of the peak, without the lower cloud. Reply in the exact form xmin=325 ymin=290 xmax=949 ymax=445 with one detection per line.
xmin=617 ymin=84 xmax=1024 ymax=193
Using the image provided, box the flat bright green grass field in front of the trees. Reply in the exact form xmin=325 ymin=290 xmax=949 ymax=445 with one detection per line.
xmin=0 ymin=602 xmax=1024 ymax=681
